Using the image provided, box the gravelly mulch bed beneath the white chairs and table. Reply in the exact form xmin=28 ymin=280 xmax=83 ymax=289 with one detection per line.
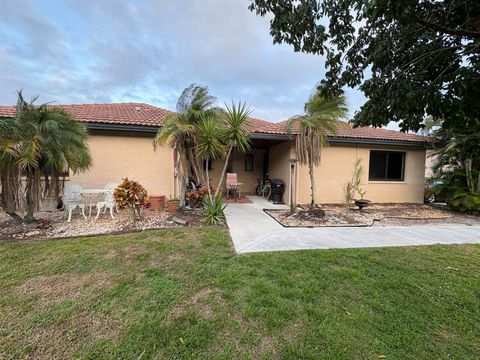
xmin=0 ymin=210 xmax=212 ymax=242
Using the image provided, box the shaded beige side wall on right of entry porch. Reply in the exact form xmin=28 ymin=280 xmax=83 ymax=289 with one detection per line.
xmin=268 ymin=141 xmax=293 ymax=204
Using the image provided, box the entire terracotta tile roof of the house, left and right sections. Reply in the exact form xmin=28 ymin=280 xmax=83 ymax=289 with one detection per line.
xmin=0 ymin=103 xmax=427 ymax=143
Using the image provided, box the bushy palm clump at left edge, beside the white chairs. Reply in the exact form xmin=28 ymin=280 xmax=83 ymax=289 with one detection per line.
xmin=0 ymin=91 xmax=91 ymax=222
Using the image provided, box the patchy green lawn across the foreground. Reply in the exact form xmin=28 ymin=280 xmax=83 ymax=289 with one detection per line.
xmin=0 ymin=228 xmax=480 ymax=359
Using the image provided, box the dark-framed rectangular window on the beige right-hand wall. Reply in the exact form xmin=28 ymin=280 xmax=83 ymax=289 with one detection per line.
xmin=368 ymin=150 xmax=405 ymax=181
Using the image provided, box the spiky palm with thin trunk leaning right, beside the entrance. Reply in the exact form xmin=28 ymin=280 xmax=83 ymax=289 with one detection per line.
xmin=215 ymin=102 xmax=251 ymax=196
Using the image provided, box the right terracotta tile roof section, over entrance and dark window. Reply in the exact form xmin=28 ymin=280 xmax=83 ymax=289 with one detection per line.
xmin=255 ymin=121 xmax=428 ymax=143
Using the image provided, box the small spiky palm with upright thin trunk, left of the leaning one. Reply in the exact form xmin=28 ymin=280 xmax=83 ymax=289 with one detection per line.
xmin=196 ymin=115 xmax=225 ymax=200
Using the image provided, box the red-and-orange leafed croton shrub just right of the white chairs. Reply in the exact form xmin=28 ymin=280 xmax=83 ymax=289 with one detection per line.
xmin=113 ymin=178 xmax=150 ymax=220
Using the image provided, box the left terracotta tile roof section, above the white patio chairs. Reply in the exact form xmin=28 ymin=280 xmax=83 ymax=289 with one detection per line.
xmin=0 ymin=103 xmax=172 ymax=126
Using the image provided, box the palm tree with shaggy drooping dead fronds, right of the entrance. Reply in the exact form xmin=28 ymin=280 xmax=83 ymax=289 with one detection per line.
xmin=286 ymin=90 xmax=348 ymax=209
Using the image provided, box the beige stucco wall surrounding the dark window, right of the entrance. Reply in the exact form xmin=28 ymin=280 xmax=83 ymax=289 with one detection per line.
xmin=297 ymin=144 xmax=425 ymax=204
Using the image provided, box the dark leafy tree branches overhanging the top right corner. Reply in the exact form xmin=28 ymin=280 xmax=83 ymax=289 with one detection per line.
xmin=249 ymin=0 xmax=480 ymax=131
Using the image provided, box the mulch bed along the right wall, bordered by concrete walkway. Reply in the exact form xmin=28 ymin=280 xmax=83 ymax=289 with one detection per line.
xmin=265 ymin=204 xmax=480 ymax=227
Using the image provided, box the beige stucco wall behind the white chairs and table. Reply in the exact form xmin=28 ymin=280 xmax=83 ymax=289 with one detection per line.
xmin=70 ymin=133 xmax=174 ymax=198
